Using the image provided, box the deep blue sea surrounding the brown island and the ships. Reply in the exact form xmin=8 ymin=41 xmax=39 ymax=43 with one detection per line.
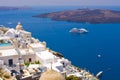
xmin=0 ymin=6 xmax=120 ymax=80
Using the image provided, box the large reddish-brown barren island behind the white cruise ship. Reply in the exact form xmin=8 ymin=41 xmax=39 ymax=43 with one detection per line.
xmin=34 ymin=9 xmax=120 ymax=24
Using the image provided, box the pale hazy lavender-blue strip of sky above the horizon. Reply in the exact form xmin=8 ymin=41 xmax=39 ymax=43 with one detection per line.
xmin=0 ymin=0 xmax=120 ymax=6
